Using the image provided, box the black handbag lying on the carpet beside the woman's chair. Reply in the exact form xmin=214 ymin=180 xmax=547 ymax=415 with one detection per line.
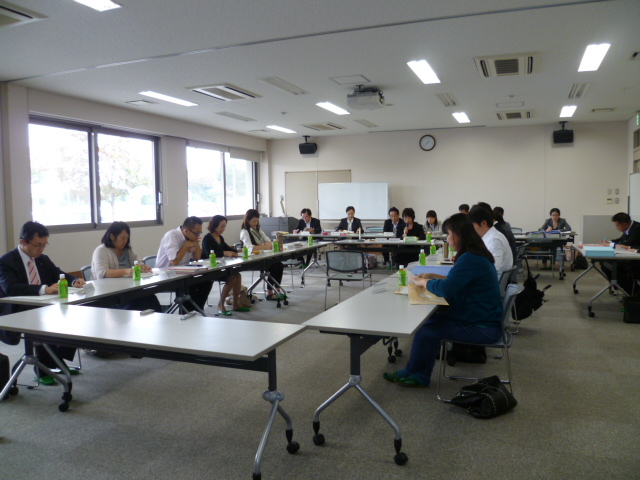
xmin=449 ymin=375 xmax=518 ymax=419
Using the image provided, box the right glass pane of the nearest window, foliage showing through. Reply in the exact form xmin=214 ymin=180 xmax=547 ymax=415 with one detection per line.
xmin=96 ymin=133 xmax=156 ymax=223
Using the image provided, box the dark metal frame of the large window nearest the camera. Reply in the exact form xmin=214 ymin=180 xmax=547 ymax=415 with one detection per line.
xmin=29 ymin=115 xmax=164 ymax=233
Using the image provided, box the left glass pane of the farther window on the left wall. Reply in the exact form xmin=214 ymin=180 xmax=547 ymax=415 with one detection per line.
xmin=187 ymin=147 xmax=224 ymax=217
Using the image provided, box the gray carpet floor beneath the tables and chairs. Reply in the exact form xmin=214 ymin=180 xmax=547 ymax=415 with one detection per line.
xmin=0 ymin=262 xmax=640 ymax=480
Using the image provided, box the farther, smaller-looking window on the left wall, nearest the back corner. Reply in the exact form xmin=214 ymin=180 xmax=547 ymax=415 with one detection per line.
xmin=187 ymin=142 xmax=259 ymax=217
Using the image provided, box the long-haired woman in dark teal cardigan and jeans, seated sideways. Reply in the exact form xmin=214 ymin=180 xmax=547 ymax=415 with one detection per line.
xmin=383 ymin=213 xmax=502 ymax=387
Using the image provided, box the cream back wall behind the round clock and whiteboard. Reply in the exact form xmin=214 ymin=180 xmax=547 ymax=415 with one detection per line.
xmin=269 ymin=122 xmax=628 ymax=233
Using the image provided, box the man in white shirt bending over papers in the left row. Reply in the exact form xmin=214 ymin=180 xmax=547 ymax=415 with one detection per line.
xmin=156 ymin=217 xmax=213 ymax=310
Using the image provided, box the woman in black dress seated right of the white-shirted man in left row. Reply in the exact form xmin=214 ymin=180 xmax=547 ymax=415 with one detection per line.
xmin=202 ymin=215 xmax=251 ymax=316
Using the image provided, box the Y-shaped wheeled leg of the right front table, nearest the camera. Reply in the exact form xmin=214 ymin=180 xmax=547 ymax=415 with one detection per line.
xmin=313 ymin=335 xmax=409 ymax=465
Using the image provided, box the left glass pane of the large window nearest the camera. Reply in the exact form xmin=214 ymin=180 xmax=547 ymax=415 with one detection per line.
xmin=29 ymin=123 xmax=91 ymax=225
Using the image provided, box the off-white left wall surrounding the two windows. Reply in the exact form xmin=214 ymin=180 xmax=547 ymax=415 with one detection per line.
xmin=0 ymin=84 xmax=268 ymax=271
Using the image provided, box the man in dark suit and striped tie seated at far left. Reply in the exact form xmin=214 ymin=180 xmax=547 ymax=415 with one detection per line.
xmin=0 ymin=221 xmax=85 ymax=385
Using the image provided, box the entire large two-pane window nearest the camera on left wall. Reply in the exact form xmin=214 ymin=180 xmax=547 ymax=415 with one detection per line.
xmin=29 ymin=119 xmax=161 ymax=230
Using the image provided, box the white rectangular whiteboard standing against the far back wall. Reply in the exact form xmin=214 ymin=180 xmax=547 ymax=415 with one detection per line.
xmin=318 ymin=182 xmax=389 ymax=220
